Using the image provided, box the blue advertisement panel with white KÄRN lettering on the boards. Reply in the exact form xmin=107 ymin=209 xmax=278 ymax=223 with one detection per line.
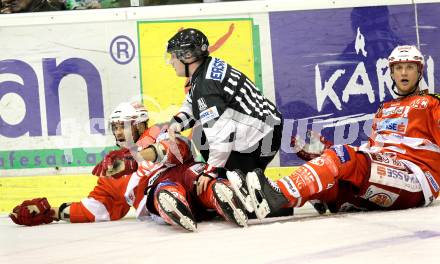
xmin=270 ymin=4 xmax=440 ymax=166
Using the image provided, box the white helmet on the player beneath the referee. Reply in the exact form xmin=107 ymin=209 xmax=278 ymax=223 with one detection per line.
xmin=109 ymin=102 xmax=149 ymax=125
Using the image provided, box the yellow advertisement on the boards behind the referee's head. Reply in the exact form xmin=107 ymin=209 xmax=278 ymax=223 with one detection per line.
xmin=138 ymin=19 xmax=255 ymax=124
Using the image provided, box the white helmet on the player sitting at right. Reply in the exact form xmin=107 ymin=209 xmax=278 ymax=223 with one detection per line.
xmin=388 ymin=45 xmax=425 ymax=73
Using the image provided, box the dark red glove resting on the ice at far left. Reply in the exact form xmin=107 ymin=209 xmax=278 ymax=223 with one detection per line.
xmin=9 ymin=198 xmax=55 ymax=226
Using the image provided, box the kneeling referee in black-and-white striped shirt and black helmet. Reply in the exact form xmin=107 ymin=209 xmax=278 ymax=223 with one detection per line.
xmin=167 ymin=28 xmax=283 ymax=194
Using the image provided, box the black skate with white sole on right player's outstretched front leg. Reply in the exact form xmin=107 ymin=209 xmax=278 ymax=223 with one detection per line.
xmin=246 ymin=169 xmax=288 ymax=220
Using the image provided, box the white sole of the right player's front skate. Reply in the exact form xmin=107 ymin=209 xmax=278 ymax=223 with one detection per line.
xmin=246 ymin=172 xmax=271 ymax=220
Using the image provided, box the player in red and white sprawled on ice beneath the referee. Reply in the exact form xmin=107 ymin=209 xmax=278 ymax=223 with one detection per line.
xmin=9 ymin=103 xmax=247 ymax=231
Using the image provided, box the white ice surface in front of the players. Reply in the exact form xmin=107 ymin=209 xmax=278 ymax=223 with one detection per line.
xmin=0 ymin=200 xmax=440 ymax=264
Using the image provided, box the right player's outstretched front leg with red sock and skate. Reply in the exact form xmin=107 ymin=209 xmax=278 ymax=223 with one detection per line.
xmin=246 ymin=145 xmax=368 ymax=219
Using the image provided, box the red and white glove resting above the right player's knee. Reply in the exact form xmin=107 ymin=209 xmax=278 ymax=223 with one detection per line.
xmin=290 ymin=130 xmax=333 ymax=161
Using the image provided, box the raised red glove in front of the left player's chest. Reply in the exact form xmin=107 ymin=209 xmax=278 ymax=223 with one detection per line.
xmin=92 ymin=148 xmax=138 ymax=178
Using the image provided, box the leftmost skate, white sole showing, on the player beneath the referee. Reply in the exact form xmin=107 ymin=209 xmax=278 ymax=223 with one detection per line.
xmin=157 ymin=190 xmax=197 ymax=231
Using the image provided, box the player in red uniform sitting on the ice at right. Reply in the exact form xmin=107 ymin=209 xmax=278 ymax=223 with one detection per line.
xmin=227 ymin=46 xmax=440 ymax=219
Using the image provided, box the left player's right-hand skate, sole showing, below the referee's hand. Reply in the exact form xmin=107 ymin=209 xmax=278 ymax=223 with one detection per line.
xmin=212 ymin=181 xmax=247 ymax=227
